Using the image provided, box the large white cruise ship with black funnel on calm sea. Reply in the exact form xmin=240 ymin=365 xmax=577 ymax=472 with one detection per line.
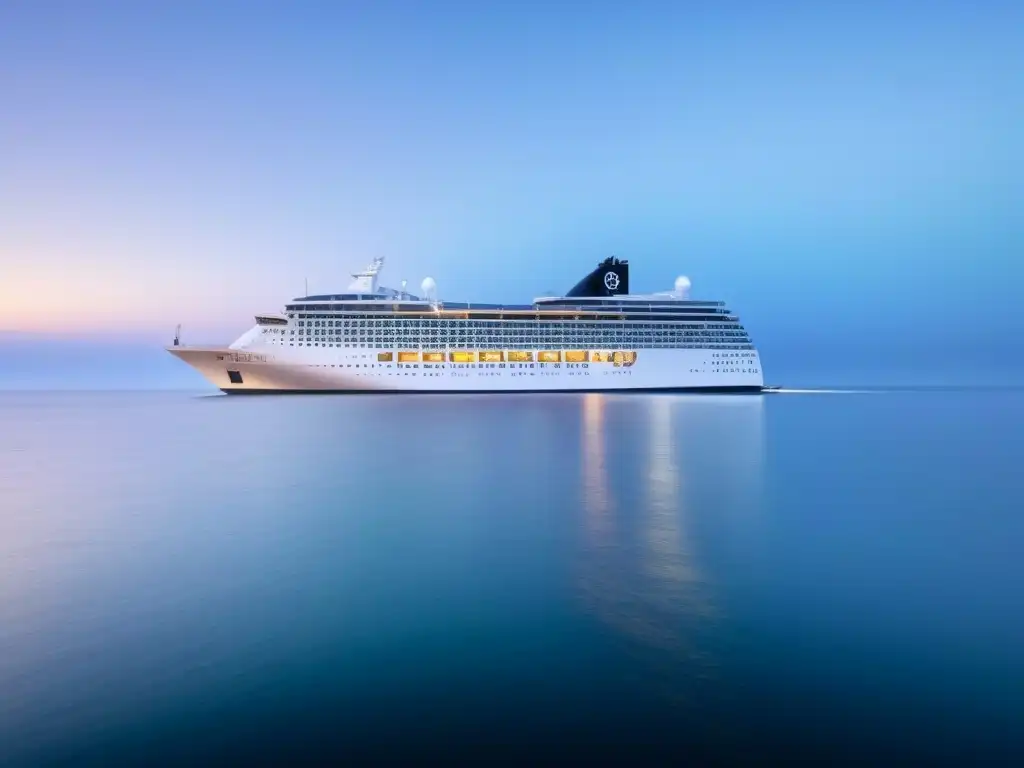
xmin=167 ymin=257 xmax=764 ymax=394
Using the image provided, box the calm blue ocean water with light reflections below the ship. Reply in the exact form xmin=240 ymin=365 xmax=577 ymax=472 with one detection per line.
xmin=0 ymin=389 xmax=1024 ymax=765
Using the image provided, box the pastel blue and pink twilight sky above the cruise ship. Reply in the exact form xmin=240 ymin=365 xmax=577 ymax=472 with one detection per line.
xmin=0 ymin=0 xmax=1024 ymax=385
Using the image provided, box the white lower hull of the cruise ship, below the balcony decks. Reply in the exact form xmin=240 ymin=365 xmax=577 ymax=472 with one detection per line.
xmin=168 ymin=343 xmax=764 ymax=393
